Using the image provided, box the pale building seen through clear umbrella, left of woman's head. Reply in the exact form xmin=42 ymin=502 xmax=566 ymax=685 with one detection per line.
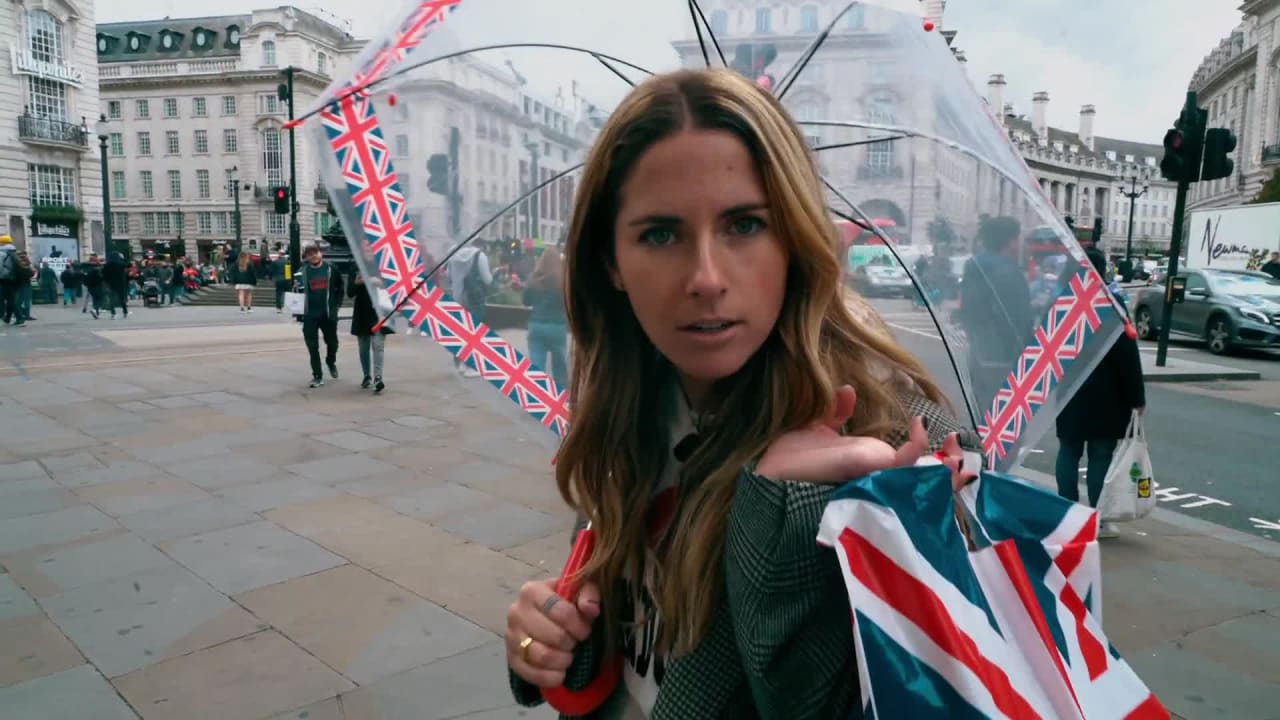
xmin=378 ymin=55 xmax=594 ymax=256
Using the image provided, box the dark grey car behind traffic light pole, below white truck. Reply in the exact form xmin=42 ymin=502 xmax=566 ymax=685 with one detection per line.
xmin=1133 ymin=268 xmax=1280 ymax=355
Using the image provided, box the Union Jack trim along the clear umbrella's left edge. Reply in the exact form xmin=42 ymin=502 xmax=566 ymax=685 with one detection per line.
xmin=320 ymin=0 xmax=568 ymax=436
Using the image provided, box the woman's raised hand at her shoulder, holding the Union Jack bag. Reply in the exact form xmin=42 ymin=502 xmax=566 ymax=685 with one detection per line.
xmin=755 ymin=386 xmax=969 ymax=487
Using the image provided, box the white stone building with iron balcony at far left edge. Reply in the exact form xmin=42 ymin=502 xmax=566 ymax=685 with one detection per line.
xmin=0 ymin=0 xmax=102 ymax=258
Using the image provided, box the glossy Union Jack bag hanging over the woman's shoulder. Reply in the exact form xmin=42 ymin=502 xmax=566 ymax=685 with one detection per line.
xmin=819 ymin=465 xmax=1170 ymax=720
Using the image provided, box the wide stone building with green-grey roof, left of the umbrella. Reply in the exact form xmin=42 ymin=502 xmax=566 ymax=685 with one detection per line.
xmin=97 ymin=6 xmax=364 ymax=258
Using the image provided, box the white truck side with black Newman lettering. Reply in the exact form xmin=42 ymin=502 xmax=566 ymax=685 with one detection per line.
xmin=1187 ymin=202 xmax=1280 ymax=270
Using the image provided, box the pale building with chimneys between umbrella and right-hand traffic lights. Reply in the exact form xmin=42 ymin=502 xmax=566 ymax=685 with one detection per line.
xmin=987 ymin=74 xmax=1176 ymax=256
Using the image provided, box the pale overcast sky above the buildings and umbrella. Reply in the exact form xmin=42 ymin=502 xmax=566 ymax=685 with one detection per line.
xmin=97 ymin=0 xmax=1239 ymax=142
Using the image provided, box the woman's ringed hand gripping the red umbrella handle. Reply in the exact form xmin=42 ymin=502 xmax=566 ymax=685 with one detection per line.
xmin=506 ymin=571 xmax=600 ymax=688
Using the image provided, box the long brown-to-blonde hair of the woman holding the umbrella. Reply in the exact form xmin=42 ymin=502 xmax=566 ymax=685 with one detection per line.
xmin=556 ymin=70 xmax=942 ymax=653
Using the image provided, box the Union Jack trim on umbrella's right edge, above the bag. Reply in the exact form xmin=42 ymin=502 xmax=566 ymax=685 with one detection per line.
xmin=978 ymin=265 xmax=1119 ymax=469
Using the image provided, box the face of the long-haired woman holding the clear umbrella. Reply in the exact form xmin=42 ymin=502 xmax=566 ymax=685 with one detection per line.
xmin=611 ymin=129 xmax=787 ymax=402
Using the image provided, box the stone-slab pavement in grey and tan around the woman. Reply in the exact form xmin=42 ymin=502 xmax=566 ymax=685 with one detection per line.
xmin=0 ymin=336 xmax=1280 ymax=720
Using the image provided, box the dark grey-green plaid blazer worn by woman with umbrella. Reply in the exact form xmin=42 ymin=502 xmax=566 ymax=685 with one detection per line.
xmin=508 ymin=397 xmax=978 ymax=720
